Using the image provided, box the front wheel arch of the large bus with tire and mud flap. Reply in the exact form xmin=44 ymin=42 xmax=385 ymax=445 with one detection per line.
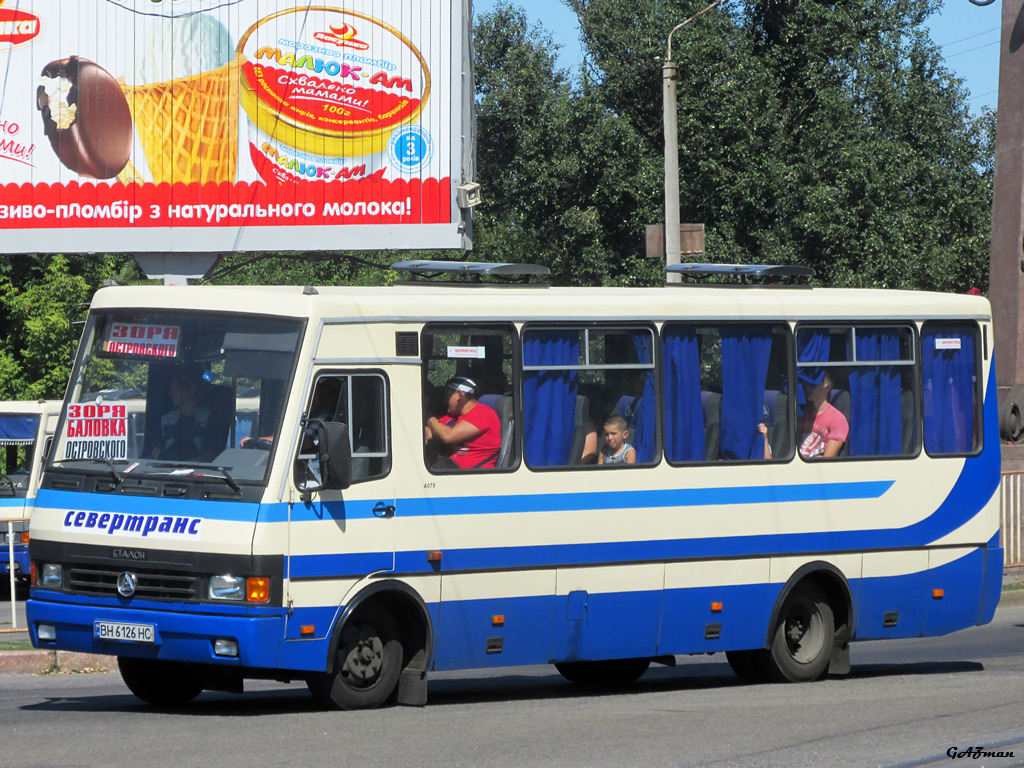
xmin=309 ymin=580 xmax=433 ymax=709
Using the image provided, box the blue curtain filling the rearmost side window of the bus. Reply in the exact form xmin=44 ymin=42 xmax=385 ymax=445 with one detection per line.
xmin=921 ymin=326 xmax=977 ymax=454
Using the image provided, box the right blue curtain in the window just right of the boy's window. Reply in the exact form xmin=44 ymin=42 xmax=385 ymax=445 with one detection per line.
xmin=722 ymin=326 xmax=772 ymax=460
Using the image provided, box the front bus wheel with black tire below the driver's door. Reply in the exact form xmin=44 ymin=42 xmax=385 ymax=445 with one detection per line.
xmin=307 ymin=603 xmax=402 ymax=710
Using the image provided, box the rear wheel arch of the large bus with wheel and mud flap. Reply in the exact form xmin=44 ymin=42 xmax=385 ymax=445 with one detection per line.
xmin=764 ymin=561 xmax=853 ymax=682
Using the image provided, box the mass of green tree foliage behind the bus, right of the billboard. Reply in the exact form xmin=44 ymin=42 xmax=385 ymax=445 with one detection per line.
xmin=475 ymin=0 xmax=993 ymax=291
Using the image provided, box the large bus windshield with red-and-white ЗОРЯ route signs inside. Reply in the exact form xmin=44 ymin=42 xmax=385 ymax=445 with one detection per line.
xmin=50 ymin=309 xmax=303 ymax=484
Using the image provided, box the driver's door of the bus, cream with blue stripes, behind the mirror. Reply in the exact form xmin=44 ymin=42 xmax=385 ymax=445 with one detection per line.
xmin=288 ymin=370 xmax=395 ymax=639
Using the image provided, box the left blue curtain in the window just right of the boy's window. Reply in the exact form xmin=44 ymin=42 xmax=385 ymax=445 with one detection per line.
xmin=663 ymin=329 xmax=705 ymax=462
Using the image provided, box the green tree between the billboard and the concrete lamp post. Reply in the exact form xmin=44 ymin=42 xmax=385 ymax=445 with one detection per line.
xmin=474 ymin=5 xmax=659 ymax=285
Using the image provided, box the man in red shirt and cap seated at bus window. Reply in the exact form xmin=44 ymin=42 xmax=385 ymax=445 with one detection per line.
xmin=426 ymin=376 xmax=502 ymax=469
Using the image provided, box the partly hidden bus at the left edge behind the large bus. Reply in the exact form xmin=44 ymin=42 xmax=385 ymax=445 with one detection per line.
xmin=0 ymin=400 xmax=61 ymax=599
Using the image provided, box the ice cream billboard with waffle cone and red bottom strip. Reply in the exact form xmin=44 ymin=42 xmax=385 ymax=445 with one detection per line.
xmin=0 ymin=0 xmax=473 ymax=254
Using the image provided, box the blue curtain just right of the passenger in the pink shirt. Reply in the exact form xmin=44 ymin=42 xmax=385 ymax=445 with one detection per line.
xmin=850 ymin=328 xmax=903 ymax=456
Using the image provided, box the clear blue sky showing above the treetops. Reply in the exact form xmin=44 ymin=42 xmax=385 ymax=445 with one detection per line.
xmin=473 ymin=0 xmax=1002 ymax=113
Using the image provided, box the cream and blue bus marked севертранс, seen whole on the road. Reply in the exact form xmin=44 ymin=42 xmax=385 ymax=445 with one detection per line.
xmin=28 ymin=262 xmax=1002 ymax=709
